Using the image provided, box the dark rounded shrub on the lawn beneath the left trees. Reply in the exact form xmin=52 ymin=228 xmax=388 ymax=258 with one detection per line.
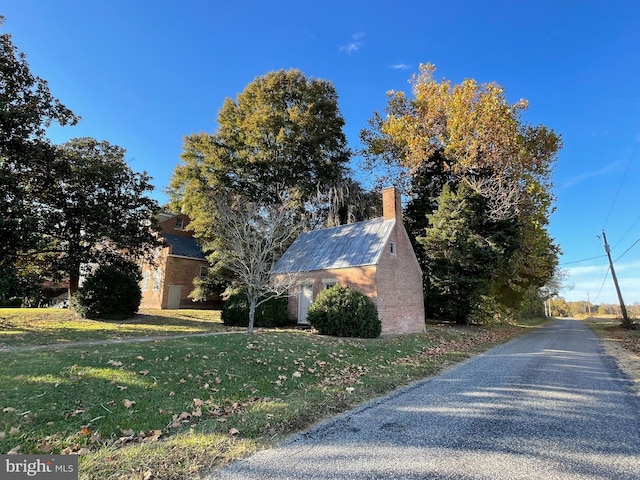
xmin=70 ymin=255 xmax=142 ymax=320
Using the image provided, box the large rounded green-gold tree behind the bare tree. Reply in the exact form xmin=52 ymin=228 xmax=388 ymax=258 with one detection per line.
xmin=168 ymin=70 xmax=350 ymax=290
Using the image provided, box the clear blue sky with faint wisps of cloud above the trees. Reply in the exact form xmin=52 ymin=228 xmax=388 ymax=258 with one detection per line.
xmin=0 ymin=0 xmax=640 ymax=303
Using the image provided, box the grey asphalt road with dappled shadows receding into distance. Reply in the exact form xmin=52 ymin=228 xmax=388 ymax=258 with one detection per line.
xmin=210 ymin=320 xmax=640 ymax=480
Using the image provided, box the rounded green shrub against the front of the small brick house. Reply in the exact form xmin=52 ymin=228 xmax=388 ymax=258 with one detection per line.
xmin=307 ymin=285 xmax=382 ymax=338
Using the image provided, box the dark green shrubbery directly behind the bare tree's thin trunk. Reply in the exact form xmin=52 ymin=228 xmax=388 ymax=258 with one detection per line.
xmin=222 ymin=288 xmax=289 ymax=328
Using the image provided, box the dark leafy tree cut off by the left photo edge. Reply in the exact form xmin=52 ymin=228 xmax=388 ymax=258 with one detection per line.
xmin=0 ymin=16 xmax=79 ymax=295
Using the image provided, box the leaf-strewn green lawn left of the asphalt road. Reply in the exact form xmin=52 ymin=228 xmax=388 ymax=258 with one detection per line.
xmin=0 ymin=310 xmax=548 ymax=479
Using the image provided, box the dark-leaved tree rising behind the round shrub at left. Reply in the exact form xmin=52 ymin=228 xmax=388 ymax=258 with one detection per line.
xmin=25 ymin=138 xmax=158 ymax=294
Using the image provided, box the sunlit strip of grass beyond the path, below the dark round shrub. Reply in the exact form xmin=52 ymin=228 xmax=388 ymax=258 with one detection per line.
xmin=0 ymin=308 xmax=233 ymax=348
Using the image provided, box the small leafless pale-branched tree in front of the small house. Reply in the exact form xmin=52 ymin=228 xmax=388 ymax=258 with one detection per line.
xmin=210 ymin=194 xmax=302 ymax=333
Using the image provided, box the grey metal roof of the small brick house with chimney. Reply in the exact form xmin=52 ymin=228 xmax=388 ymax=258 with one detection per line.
xmin=272 ymin=218 xmax=396 ymax=273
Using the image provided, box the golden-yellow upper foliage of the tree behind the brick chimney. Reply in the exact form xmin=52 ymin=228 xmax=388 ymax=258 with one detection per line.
xmin=380 ymin=64 xmax=527 ymax=178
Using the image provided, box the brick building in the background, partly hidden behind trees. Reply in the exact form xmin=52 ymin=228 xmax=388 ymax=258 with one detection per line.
xmin=140 ymin=213 xmax=219 ymax=309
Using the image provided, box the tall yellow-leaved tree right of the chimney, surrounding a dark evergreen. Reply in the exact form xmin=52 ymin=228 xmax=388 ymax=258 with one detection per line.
xmin=361 ymin=64 xmax=561 ymax=318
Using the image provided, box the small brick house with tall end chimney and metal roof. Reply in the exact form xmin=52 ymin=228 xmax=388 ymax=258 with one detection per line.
xmin=273 ymin=187 xmax=425 ymax=335
